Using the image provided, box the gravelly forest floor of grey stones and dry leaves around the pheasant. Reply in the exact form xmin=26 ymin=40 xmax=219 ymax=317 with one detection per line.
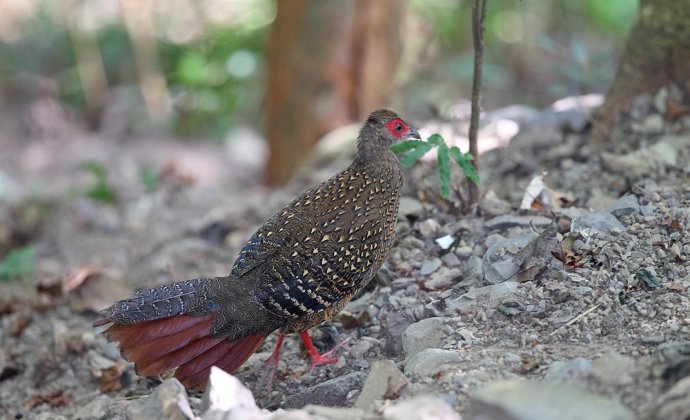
xmin=0 ymin=88 xmax=690 ymax=419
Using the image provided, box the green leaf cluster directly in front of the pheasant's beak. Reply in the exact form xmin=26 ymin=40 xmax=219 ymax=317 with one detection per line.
xmin=391 ymin=134 xmax=479 ymax=199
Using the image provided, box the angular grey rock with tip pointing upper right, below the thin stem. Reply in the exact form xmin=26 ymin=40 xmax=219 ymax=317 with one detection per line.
xmin=482 ymin=231 xmax=536 ymax=284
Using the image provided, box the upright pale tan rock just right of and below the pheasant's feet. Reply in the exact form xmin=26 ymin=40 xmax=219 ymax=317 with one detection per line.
xmin=355 ymin=360 xmax=407 ymax=409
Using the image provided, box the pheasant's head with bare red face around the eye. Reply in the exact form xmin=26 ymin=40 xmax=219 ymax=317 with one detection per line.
xmin=358 ymin=109 xmax=421 ymax=158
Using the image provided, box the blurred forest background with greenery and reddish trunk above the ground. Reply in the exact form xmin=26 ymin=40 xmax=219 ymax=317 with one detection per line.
xmin=0 ymin=0 xmax=638 ymax=185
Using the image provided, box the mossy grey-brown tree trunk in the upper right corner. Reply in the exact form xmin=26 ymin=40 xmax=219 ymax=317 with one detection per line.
xmin=592 ymin=0 xmax=690 ymax=142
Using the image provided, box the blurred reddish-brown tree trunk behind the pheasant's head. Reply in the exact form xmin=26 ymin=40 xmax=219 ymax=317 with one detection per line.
xmin=264 ymin=0 xmax=404 ymax=185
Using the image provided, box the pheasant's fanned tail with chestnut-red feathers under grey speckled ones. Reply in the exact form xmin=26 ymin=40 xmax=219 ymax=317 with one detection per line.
xmin=94 ymin=279 xmax=266 ymax=388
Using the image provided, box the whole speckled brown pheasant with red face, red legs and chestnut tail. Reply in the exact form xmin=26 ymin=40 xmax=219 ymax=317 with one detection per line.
xmin=94 ymin=109 xmax=420 ymax=388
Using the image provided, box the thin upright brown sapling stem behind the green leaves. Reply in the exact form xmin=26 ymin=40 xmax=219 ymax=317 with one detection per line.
xmin=467 ymin=0 xmax=488 ymax=213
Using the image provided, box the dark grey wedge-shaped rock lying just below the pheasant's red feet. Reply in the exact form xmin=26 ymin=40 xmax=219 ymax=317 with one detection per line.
xmin=285 ymin=372 xmax=367 ymax=408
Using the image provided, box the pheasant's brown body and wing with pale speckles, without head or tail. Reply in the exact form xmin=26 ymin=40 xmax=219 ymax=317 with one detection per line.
xmin=232 ymin=159 xmax=402 ymax=330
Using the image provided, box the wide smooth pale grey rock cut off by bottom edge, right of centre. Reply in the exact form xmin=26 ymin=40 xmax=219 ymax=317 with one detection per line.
xmin=468 ymin=381 xmax=636 ymax=420
